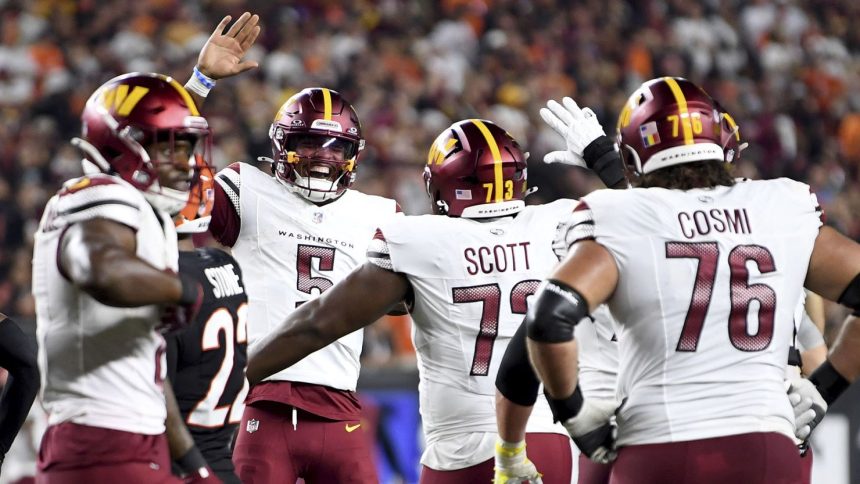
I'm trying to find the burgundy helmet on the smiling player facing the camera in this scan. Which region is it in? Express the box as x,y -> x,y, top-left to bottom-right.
269,87 -> 364,203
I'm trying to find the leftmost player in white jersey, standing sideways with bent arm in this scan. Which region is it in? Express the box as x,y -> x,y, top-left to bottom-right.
33,73 -> 210,483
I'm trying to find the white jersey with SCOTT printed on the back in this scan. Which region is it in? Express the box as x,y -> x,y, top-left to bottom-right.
370,200 -> 575,470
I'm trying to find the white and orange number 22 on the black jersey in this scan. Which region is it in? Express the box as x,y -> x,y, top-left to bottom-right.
187,304 -> 248,427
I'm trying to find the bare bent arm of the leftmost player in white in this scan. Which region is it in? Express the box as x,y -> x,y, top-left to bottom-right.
59,218 -> 191,307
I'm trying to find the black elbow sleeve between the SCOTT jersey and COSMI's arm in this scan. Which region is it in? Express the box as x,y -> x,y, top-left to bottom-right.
496,323 -> 540,407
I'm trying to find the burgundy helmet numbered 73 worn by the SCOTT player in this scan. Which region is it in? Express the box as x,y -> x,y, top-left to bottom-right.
424,119 -> 527,218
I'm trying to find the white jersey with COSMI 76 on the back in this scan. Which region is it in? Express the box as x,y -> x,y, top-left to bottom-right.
557,179 -> 822,445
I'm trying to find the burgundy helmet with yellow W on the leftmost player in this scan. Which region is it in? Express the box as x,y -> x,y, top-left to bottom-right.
72,72 -> 212,216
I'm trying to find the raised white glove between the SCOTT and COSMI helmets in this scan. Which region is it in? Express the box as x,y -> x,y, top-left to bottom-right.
540,97 -> 606,168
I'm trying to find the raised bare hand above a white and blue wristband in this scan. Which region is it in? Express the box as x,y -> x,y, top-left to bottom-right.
197,12 -> 260,79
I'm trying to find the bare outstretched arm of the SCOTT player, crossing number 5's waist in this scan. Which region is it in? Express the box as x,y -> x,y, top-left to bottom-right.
247,262 -> 410,385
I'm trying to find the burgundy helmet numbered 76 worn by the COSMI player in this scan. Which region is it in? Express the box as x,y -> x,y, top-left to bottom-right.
617,77 -> 726,175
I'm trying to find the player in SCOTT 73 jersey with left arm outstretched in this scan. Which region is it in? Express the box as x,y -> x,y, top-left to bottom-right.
248,120 -> 573,483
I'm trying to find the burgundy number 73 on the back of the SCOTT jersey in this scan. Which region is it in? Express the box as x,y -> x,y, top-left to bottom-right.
451,279 -> 540,376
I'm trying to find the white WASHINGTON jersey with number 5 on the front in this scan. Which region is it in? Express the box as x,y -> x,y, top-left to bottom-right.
216,164 -> 397,391
